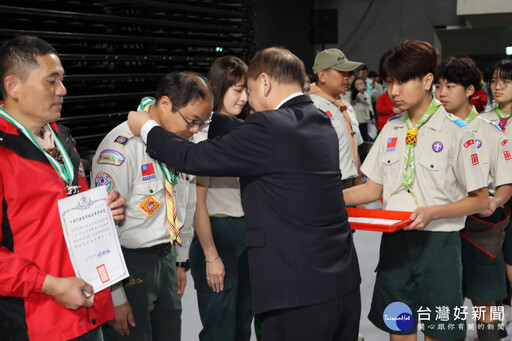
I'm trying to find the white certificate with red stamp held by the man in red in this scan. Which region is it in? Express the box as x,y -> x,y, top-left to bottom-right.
58,186 -> 128,293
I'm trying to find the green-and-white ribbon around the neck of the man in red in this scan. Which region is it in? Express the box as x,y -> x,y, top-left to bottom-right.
0,107 -> 80,195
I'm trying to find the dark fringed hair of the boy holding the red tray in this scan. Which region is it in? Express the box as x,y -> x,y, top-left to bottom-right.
379,40 -> 438,82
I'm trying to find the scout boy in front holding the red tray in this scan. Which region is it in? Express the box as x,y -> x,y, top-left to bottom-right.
343,40 -> 489,340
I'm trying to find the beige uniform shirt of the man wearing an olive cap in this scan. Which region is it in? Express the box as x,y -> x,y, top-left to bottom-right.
310,95 -> 359,180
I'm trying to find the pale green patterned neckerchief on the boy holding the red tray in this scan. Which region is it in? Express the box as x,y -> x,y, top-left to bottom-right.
391,97 -> 441,205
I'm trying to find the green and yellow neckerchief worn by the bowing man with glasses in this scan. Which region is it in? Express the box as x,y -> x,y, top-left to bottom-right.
137,97 -> 181,245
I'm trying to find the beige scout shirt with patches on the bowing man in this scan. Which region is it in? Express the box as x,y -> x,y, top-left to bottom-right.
91,122 -> 196,255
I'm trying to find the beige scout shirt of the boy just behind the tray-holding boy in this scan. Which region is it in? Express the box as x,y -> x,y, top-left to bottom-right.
468,115 -> 512,194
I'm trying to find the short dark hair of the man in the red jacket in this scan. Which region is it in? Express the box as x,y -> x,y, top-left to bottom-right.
0,36 -> 57,100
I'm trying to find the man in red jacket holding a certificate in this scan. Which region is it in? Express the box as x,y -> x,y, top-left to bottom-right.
0,36 -> 126,341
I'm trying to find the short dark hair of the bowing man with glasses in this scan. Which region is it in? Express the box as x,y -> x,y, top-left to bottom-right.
155,71 -> 213,112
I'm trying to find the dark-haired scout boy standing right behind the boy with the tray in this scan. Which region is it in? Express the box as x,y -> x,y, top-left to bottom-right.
435,58 -> 512,341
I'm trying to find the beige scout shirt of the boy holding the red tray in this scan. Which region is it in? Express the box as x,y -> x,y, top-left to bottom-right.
361,106 -> 487,231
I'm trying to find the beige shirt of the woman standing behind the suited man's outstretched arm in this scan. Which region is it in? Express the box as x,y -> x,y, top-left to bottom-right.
193,132 -> 244,217
